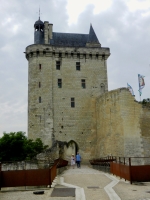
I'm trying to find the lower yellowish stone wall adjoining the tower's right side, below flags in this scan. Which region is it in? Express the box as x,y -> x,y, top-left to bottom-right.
96,88 -> 150,157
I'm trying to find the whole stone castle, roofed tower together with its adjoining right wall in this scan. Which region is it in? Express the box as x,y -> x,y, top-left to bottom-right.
25,18 -> 150,162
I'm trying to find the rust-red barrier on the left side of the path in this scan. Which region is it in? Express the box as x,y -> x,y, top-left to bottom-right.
0,163 -> 57,189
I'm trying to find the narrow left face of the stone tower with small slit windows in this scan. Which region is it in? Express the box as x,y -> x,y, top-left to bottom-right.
28,45 -> 53,146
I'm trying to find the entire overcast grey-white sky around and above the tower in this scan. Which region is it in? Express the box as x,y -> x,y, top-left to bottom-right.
0,0 -> 150,137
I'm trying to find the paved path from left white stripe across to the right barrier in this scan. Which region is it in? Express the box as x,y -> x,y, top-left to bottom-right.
58,166 -> 150,200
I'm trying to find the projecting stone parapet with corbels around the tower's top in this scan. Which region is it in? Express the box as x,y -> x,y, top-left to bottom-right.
25,45 -> 110,60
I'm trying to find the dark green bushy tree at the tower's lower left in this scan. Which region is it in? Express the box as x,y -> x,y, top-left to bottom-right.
0,132 -> 48,161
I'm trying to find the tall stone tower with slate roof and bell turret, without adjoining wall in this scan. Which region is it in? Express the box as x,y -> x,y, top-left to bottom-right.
26,18 -> 110,160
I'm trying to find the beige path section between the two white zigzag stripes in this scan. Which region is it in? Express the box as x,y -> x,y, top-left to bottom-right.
59,166 -> 119,200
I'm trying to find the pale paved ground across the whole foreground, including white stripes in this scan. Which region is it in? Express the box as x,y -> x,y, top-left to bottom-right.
0,166 -> 150,200
